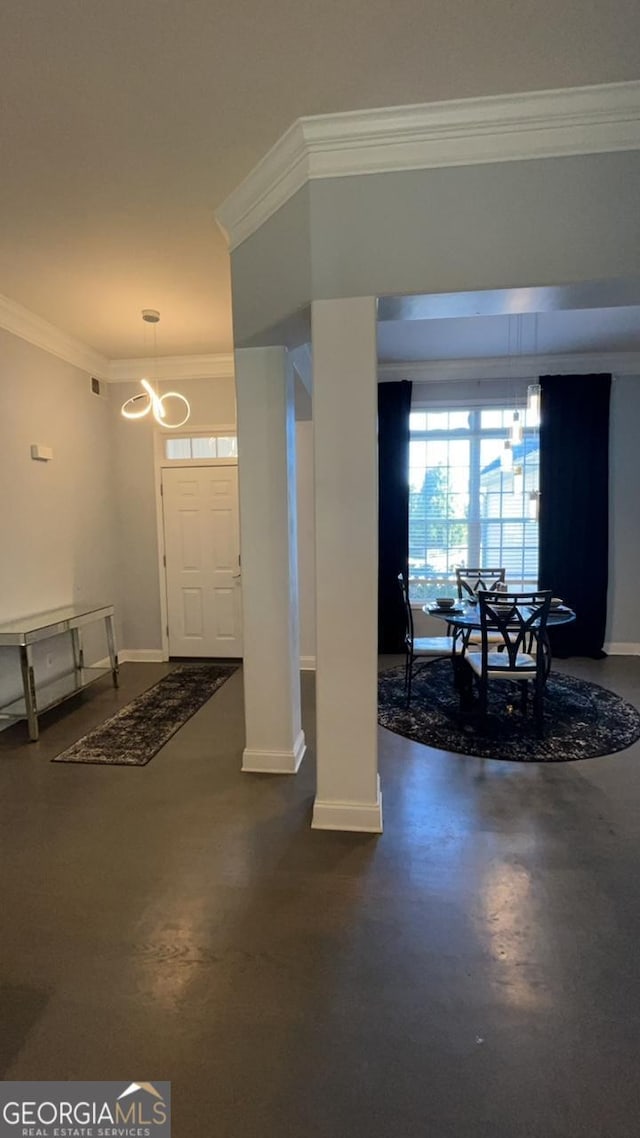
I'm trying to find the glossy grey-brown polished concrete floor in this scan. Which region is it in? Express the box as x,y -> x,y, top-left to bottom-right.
0,658 -> 640,1138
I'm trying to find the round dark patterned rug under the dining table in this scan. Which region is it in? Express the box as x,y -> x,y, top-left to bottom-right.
378,660 -> 640,762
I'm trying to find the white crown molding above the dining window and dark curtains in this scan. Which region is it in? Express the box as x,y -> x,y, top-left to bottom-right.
378,352 -> 640,382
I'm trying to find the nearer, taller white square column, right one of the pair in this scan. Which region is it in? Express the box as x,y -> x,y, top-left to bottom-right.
311,297 -> 383,833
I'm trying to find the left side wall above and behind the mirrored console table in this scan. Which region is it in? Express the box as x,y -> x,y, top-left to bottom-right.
0,331 -> 120,700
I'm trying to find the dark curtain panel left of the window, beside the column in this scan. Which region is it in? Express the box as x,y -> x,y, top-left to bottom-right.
378,380 -> 411,652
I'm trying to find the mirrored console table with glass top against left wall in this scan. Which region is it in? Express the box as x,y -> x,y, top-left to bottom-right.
0,604 -> 118,741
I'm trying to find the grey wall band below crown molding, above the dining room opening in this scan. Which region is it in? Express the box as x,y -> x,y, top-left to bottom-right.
305,150 -> 640,307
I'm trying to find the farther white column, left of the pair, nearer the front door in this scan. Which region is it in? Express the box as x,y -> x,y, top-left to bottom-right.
236,348 -> 305,774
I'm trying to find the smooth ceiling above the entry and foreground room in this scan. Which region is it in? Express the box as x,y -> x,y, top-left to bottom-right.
0,0 -> 640,358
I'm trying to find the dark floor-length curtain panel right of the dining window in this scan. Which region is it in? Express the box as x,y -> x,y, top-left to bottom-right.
540,376 -> 612,659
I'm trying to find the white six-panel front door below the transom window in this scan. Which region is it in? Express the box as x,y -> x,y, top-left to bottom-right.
162,465 -> 243,657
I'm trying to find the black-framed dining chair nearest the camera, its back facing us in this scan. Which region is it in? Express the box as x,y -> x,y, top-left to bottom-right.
465,589 -> 551,735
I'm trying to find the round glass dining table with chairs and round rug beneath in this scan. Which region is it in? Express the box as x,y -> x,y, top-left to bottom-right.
379,566 -> 640,761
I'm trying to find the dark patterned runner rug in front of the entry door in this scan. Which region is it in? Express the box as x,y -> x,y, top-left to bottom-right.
51,663 -> 237,767
